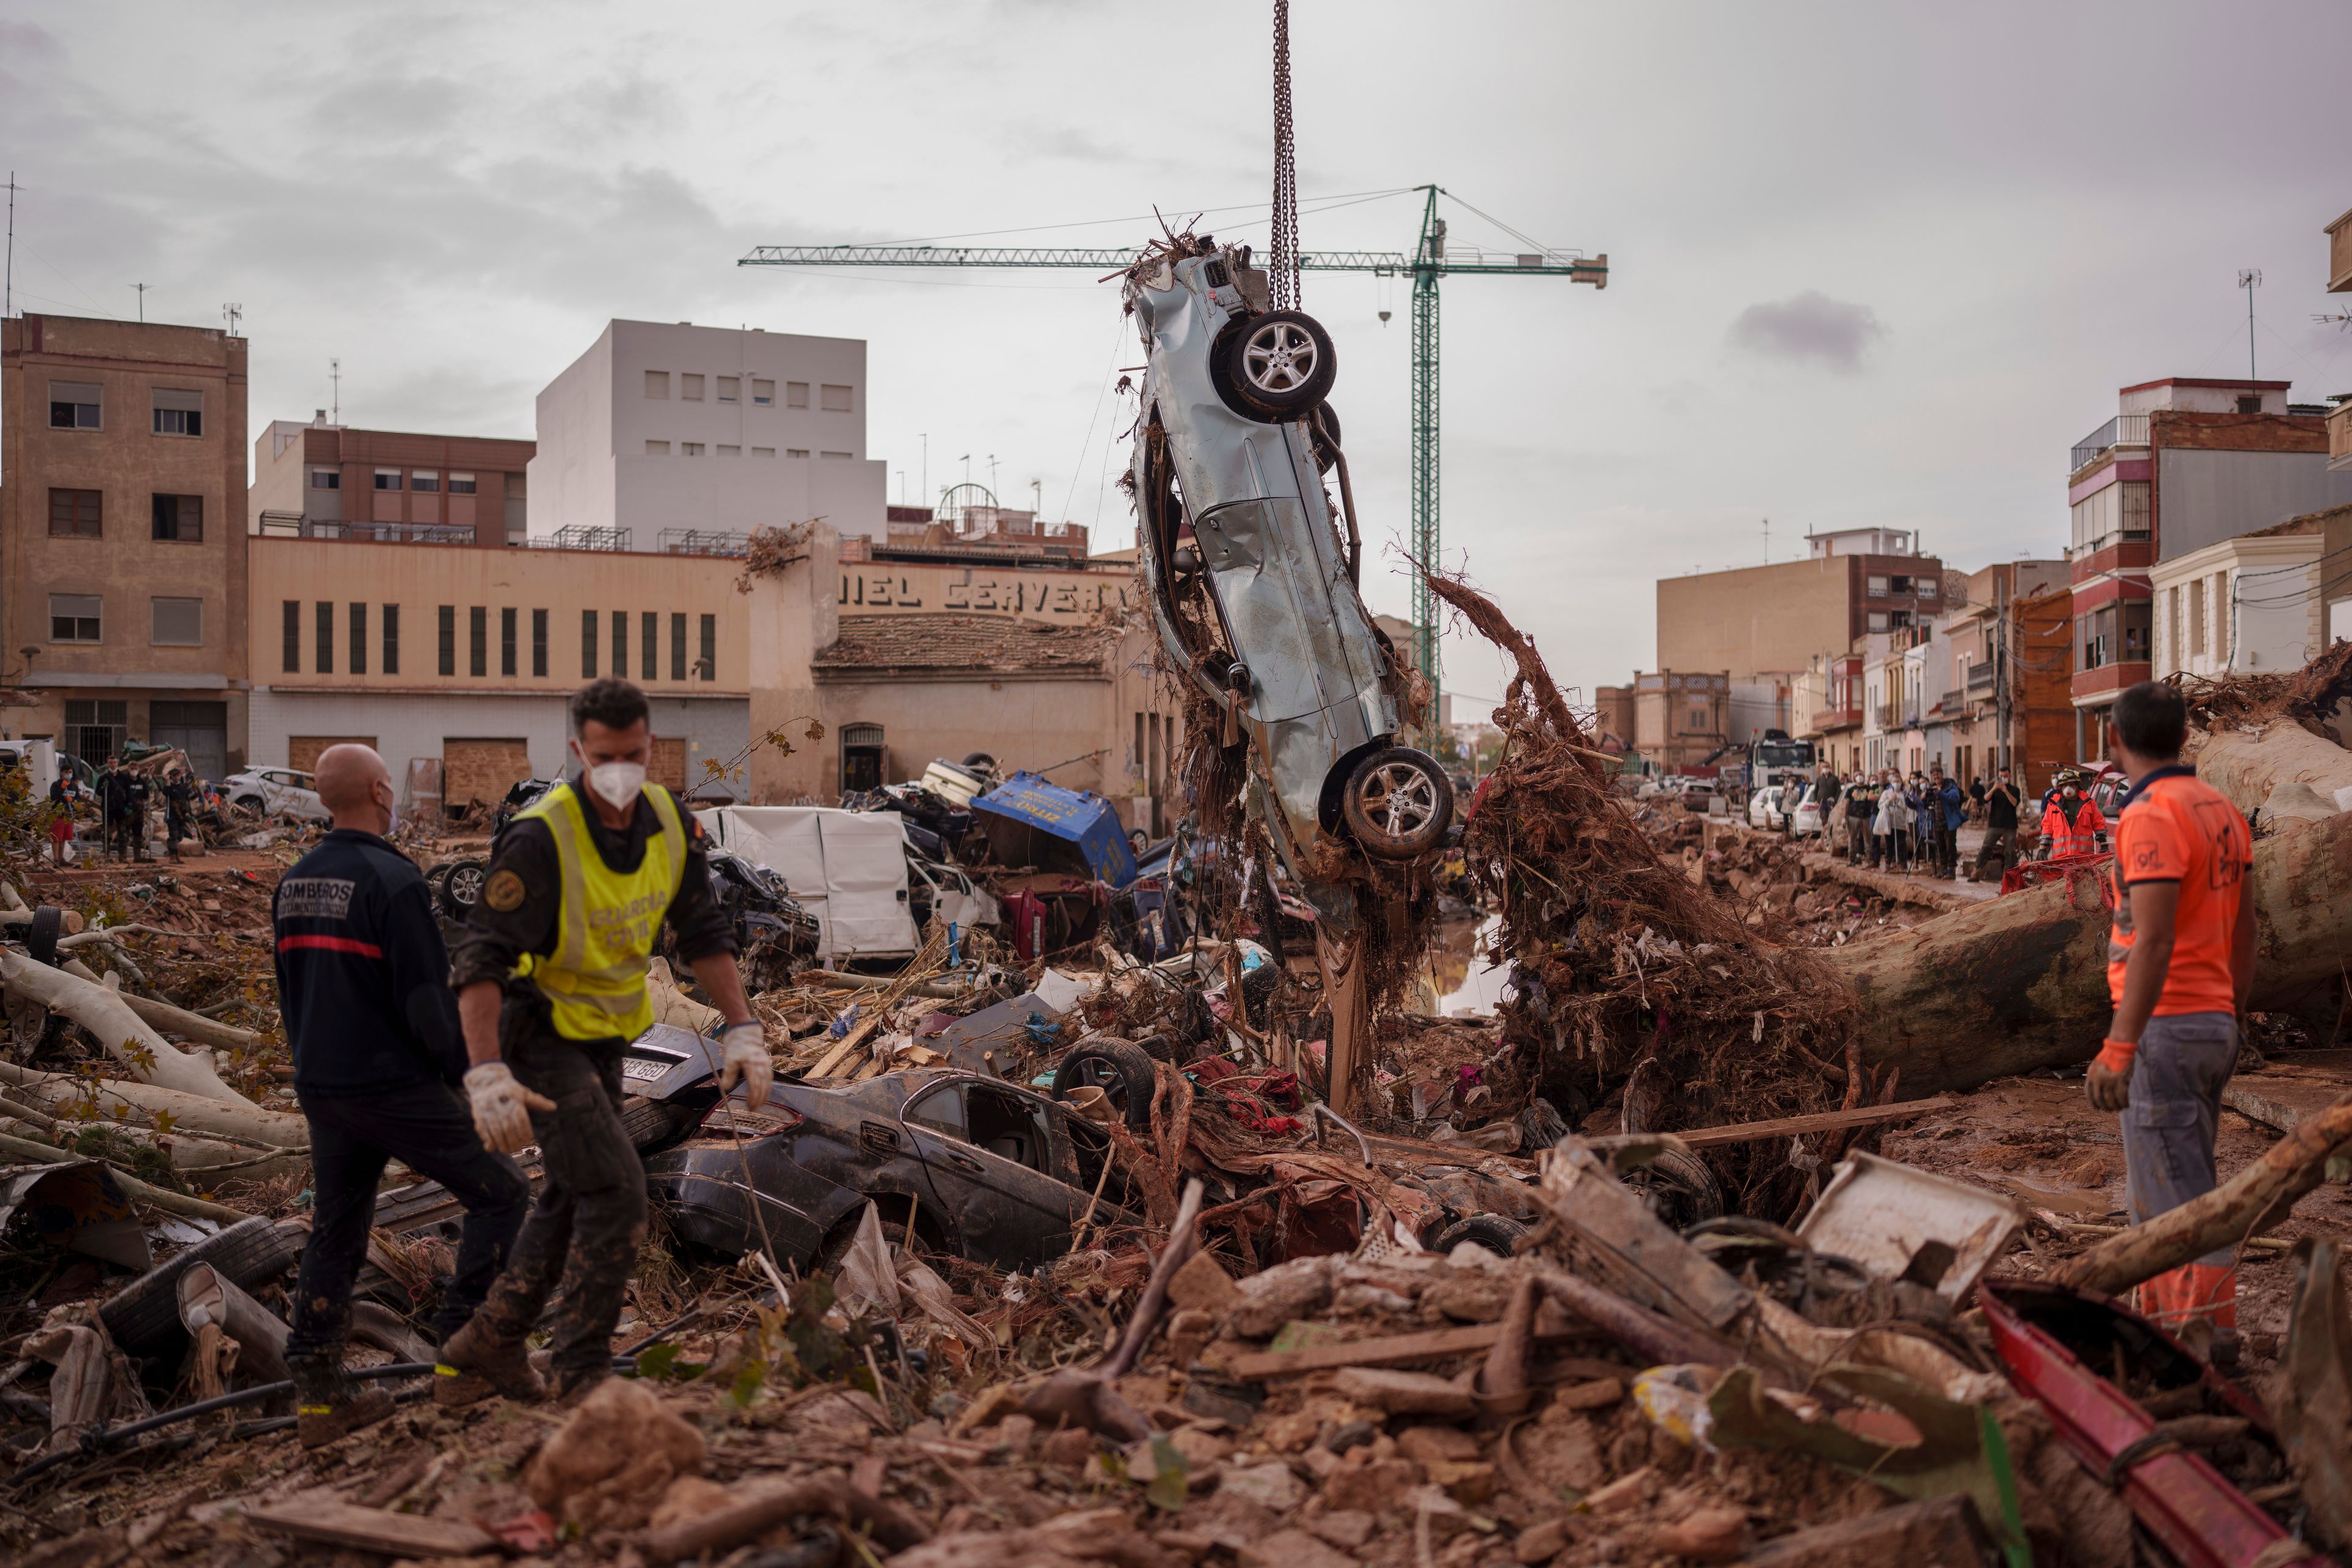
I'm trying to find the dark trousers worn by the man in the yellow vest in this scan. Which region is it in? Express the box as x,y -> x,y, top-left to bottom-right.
463,1025 -> 647,1394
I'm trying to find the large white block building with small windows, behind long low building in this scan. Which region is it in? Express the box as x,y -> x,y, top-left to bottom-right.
529,320 -> 887,550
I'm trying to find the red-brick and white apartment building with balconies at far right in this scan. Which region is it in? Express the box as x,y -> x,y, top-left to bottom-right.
2067,376 -> 2352,762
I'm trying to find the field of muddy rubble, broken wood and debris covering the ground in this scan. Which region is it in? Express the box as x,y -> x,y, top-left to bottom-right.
0,620 -> 2352,1568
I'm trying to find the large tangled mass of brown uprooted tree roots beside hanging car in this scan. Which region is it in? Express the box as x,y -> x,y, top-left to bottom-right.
1425,573 -> 1865,1218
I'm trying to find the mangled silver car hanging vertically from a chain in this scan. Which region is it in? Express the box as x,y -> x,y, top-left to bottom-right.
1125,238 -> 1453,903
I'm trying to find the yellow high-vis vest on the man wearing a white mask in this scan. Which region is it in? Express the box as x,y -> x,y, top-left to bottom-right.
515,783 -> 687,1039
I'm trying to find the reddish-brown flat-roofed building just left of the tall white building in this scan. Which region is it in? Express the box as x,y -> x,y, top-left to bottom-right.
244,409 -> 534,548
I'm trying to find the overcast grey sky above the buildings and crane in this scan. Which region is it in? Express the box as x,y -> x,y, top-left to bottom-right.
0,0 -> 2352,698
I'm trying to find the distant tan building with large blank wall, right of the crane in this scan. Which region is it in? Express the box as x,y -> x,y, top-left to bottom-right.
1658,529 -> 1943,679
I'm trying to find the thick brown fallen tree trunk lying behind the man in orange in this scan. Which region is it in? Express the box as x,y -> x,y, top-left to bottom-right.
1820,816 -> 2352,1096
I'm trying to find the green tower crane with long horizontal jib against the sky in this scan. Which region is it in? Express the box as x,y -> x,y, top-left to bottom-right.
736,186 -> 1609,696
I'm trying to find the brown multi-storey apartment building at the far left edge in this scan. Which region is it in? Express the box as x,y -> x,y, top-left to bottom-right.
0,312 -> 247,774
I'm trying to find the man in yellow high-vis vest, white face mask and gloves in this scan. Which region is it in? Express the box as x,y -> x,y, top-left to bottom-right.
435,679 -> 774,1406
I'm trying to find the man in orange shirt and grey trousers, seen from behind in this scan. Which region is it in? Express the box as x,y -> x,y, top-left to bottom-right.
2084,682 -> 2253,1344
